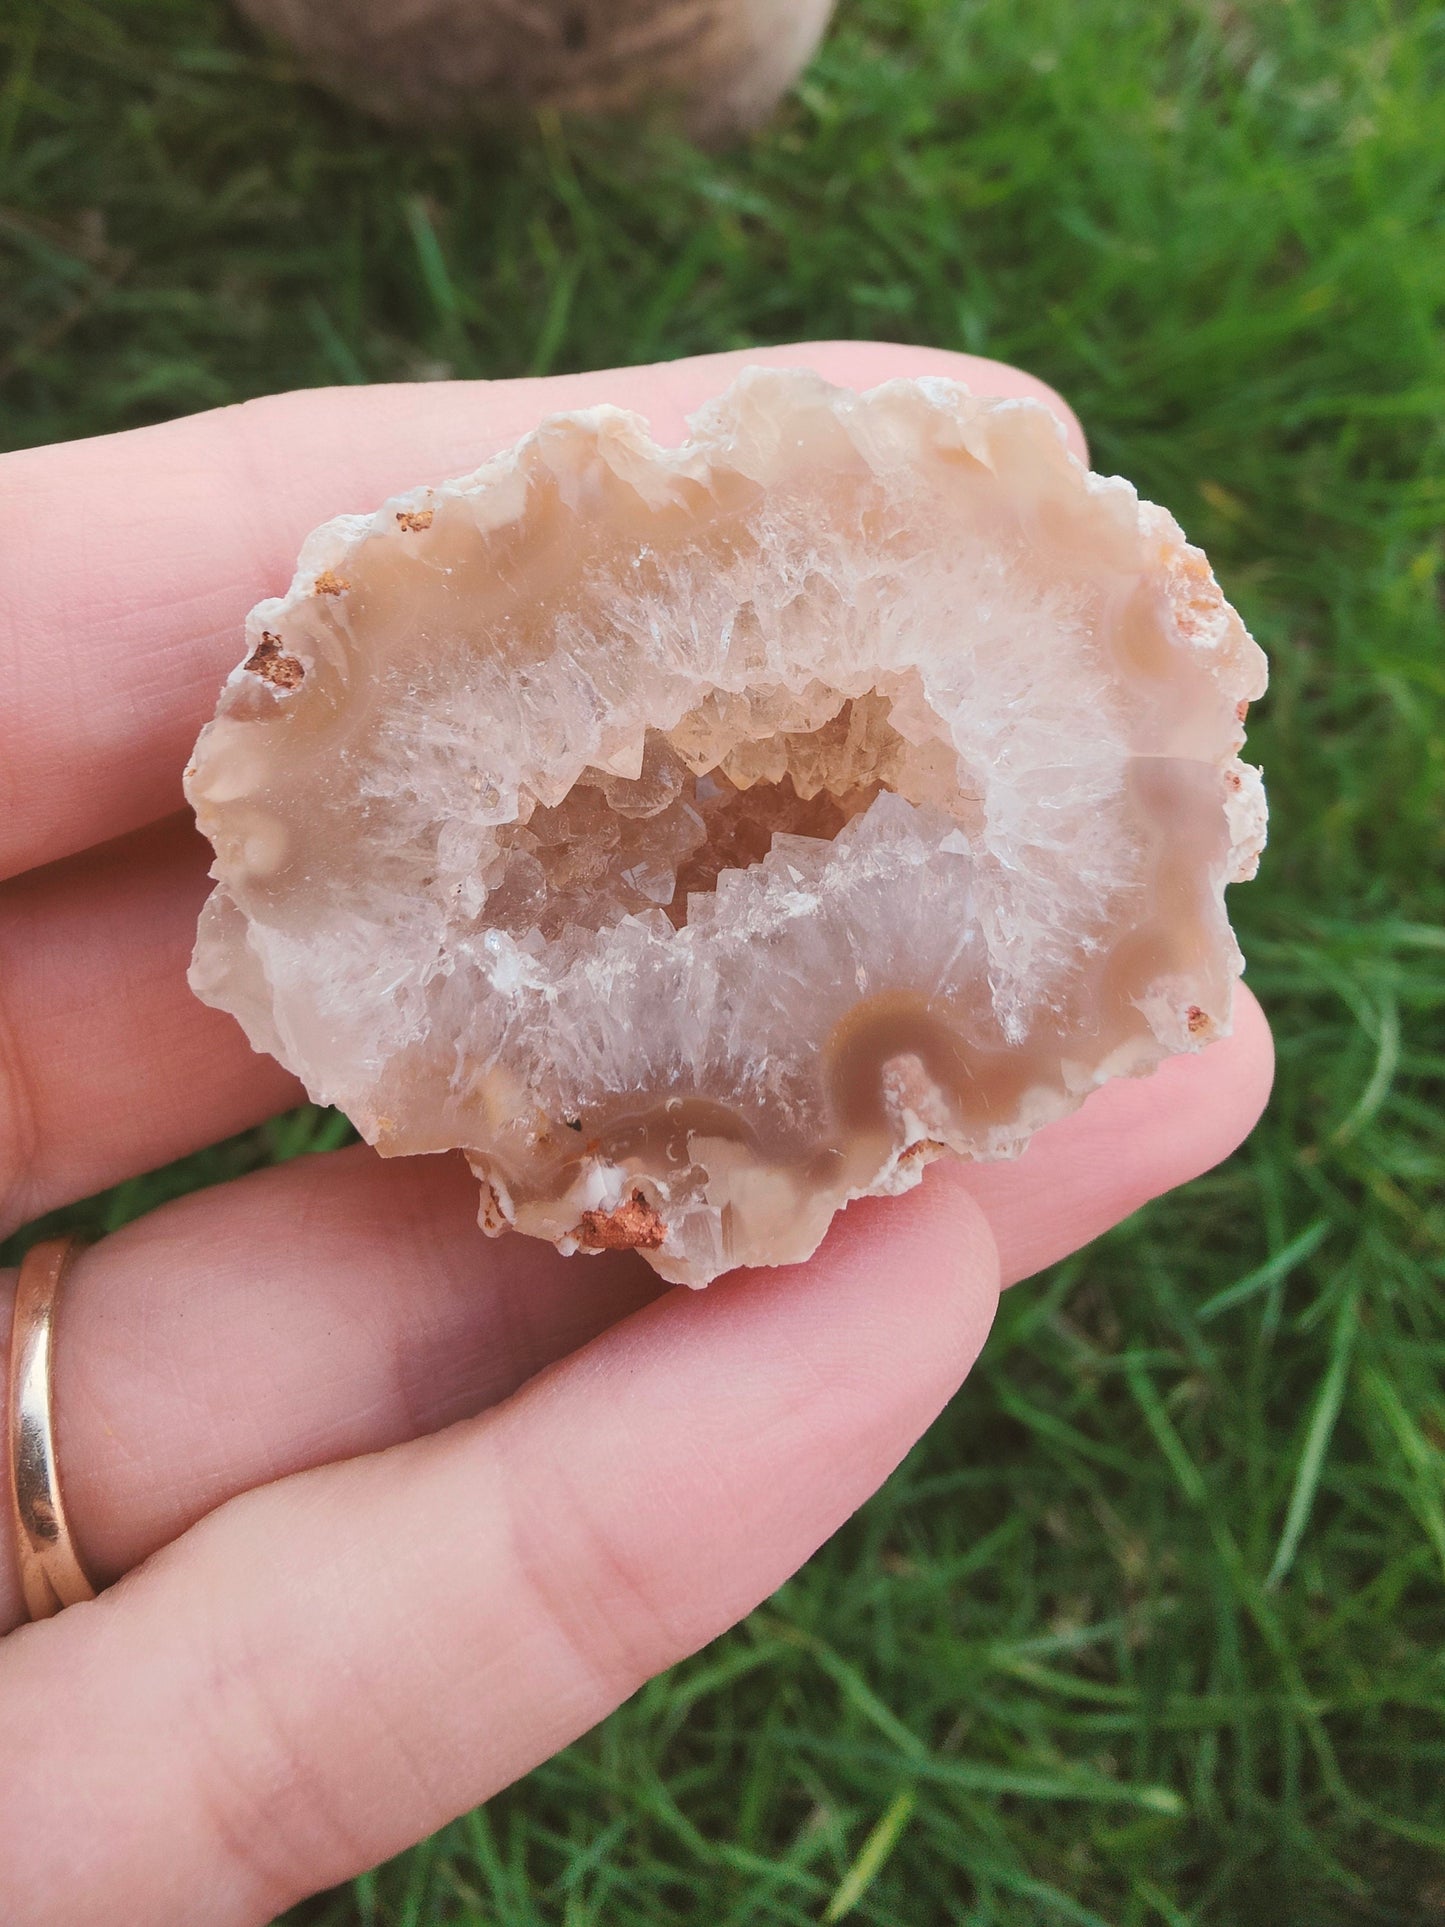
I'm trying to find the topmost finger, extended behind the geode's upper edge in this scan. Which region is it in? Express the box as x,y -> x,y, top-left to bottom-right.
0,341 -> 1085,877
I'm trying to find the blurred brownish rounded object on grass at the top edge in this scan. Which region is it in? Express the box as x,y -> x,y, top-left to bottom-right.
237,0 -> 834,141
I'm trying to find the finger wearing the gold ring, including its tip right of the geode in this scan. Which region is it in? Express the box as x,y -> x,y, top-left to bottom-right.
0,990 -> 1270,1630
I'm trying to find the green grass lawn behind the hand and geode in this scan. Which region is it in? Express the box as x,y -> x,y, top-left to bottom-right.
0,0 -> 1445,1927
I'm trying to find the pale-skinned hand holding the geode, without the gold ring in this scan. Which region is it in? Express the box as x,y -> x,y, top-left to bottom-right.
0,343 -> 1272,1927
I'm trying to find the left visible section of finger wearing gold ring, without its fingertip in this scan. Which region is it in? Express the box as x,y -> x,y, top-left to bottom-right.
0,1145 -> 661,1632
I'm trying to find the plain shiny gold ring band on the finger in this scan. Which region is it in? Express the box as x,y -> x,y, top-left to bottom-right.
10,1237 -> 94,1619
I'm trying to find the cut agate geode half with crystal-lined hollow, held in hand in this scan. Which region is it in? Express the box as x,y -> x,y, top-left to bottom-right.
187,370 -> 1264,1283
